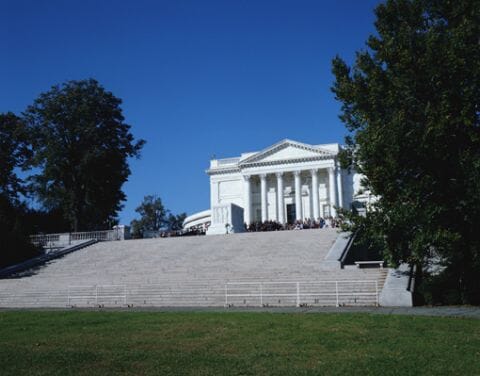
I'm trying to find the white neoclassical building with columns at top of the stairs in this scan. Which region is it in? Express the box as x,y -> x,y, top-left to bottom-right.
185,140 -> 368,231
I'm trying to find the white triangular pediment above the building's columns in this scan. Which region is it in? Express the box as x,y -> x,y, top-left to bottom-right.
241,140 -> 333,165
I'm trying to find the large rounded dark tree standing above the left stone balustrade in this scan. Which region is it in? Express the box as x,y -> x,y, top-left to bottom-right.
24,79 -> 145,231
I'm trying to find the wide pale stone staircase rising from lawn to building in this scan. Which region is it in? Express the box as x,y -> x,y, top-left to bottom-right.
0,229 -> 386,307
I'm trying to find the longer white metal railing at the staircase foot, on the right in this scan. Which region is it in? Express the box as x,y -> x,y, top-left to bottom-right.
225,280 -> 379,307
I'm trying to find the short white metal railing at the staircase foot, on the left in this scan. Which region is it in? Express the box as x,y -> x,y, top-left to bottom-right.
67,285 -> 127,306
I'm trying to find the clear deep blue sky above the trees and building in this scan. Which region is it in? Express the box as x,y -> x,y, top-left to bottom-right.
0,0 -> 380,223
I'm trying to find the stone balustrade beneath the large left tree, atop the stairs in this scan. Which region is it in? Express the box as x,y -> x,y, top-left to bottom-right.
30,229 -> 122,248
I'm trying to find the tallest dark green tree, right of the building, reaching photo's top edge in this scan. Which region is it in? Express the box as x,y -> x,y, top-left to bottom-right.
332,0 -> 480,304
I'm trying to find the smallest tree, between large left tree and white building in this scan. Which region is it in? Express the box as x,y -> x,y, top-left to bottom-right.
130,195 -> 167,238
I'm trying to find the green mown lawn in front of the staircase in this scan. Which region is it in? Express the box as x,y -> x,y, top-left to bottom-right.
0,311 -> 480,375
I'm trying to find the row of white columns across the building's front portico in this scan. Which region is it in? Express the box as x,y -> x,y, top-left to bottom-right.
243,167 -> 343,223
